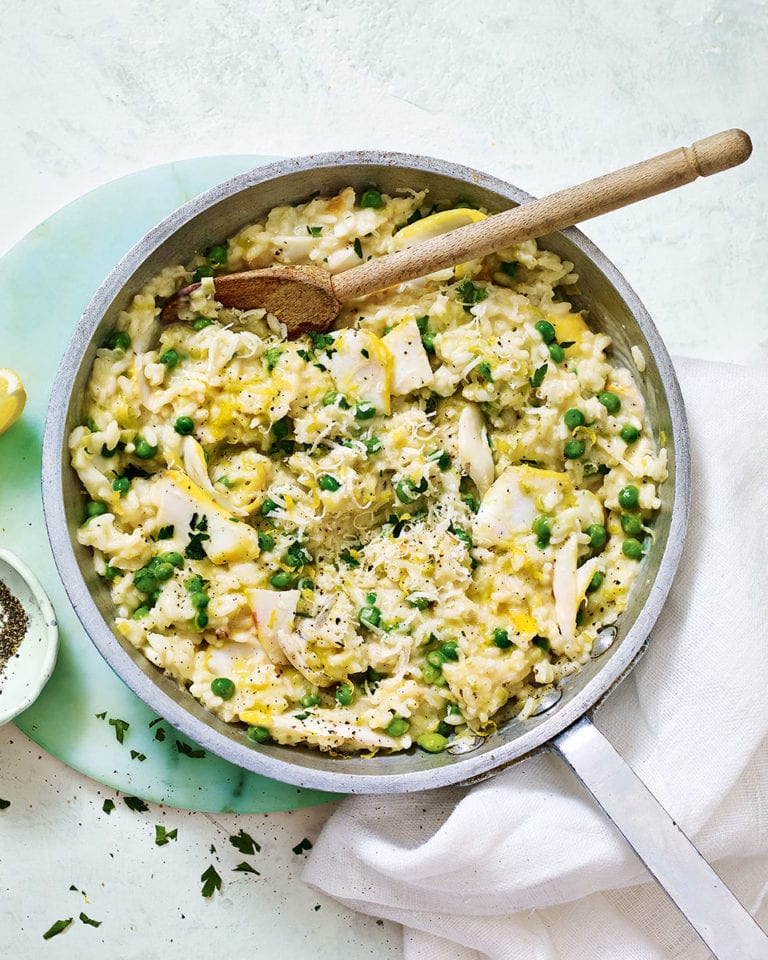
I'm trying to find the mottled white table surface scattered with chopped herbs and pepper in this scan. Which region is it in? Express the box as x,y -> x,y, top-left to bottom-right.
0,0 -> 768,960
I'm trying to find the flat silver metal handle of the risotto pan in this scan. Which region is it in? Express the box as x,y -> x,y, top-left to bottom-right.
553,717 -> 768,960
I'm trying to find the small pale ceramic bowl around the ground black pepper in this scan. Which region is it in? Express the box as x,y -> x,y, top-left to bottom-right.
0,549 -> 59,724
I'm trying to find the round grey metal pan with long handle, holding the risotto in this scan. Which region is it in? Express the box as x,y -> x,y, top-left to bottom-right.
43,152 -> 768,960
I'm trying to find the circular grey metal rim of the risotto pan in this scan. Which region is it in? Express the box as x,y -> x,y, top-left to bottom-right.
42,150 -> 691,794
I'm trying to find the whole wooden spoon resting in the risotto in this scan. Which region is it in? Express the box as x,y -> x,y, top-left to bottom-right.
160,129 -> 752,337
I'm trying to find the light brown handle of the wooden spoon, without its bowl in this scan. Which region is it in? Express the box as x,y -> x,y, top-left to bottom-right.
332,130 -> 752,302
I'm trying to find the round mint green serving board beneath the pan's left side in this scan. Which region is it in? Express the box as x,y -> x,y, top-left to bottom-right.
0,156 -> 335,813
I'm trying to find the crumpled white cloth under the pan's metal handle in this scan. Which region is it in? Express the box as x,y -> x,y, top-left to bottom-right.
304,360 -> 768,960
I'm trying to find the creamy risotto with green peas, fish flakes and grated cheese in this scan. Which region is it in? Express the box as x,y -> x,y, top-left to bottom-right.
69,188 -> 666,753
